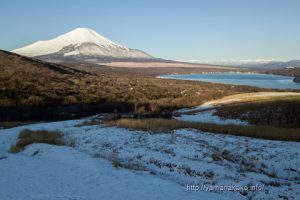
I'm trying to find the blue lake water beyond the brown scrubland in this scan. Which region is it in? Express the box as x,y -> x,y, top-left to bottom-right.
160,73 -> 300,89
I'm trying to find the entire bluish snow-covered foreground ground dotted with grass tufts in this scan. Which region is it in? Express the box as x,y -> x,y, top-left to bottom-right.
0,118 -> 300,200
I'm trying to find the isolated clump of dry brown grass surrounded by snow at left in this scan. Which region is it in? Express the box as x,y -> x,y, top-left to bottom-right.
10,129 -> 63,153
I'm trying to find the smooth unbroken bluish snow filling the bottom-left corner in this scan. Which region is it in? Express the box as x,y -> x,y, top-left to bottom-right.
0,144 -> 224,200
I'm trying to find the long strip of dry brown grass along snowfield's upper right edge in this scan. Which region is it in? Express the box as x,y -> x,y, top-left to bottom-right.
107,118 -> 300,142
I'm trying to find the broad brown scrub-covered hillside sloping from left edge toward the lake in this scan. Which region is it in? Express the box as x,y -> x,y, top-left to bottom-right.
0,51 -> 264,121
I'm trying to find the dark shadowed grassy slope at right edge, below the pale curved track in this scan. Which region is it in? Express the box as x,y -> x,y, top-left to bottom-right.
216,96 -> 300,128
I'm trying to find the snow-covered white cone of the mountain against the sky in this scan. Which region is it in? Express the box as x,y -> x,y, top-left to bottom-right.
12,28 -> 156,62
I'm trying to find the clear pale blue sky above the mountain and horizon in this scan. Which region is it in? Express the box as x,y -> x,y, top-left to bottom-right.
0,0 -> 300,62
